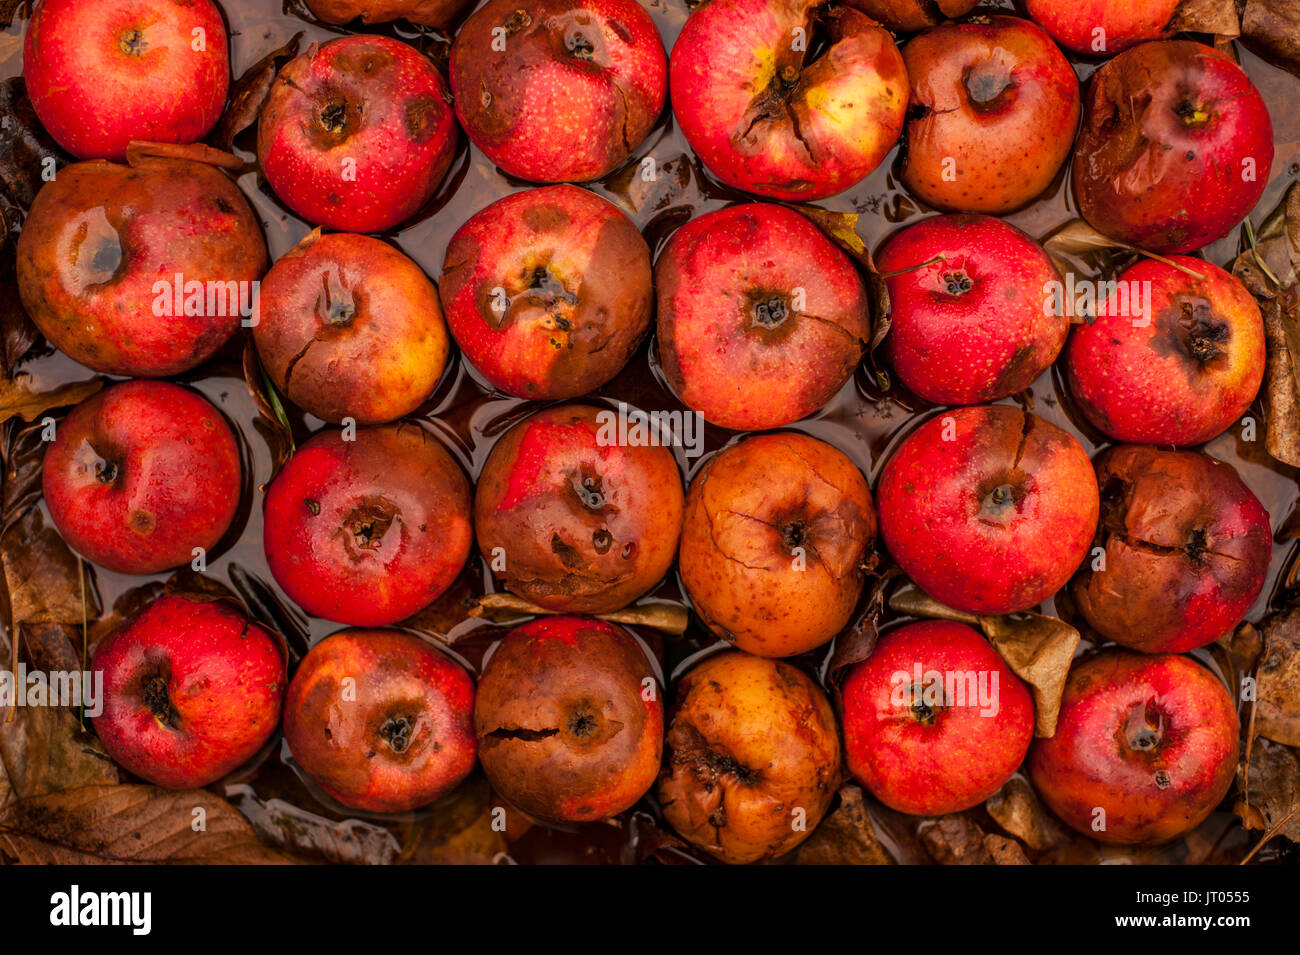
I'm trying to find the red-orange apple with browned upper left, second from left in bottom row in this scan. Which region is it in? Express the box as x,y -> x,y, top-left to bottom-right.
285,630 -> 476,812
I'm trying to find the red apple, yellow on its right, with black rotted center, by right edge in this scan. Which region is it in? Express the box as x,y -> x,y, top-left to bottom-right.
1065,256 -> 1265,446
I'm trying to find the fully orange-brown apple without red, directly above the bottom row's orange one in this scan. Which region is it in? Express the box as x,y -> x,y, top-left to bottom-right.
679,433 -> 876,656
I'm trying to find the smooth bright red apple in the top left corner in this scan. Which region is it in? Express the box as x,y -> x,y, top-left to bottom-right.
22,0 -> 230,160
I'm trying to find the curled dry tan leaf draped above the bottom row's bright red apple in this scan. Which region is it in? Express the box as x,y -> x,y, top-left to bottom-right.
889,583 -> 1079,737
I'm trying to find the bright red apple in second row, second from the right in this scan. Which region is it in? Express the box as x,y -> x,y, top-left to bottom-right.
876,216 -> 1070,404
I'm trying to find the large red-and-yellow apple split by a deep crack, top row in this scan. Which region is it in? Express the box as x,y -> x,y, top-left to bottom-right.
670,0 -> 907,201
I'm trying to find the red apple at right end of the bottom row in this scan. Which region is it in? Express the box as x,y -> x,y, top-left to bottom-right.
1027,650 -> 1239,845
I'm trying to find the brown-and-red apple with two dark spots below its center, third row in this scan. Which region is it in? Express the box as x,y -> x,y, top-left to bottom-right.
475,404 -> 683,613
